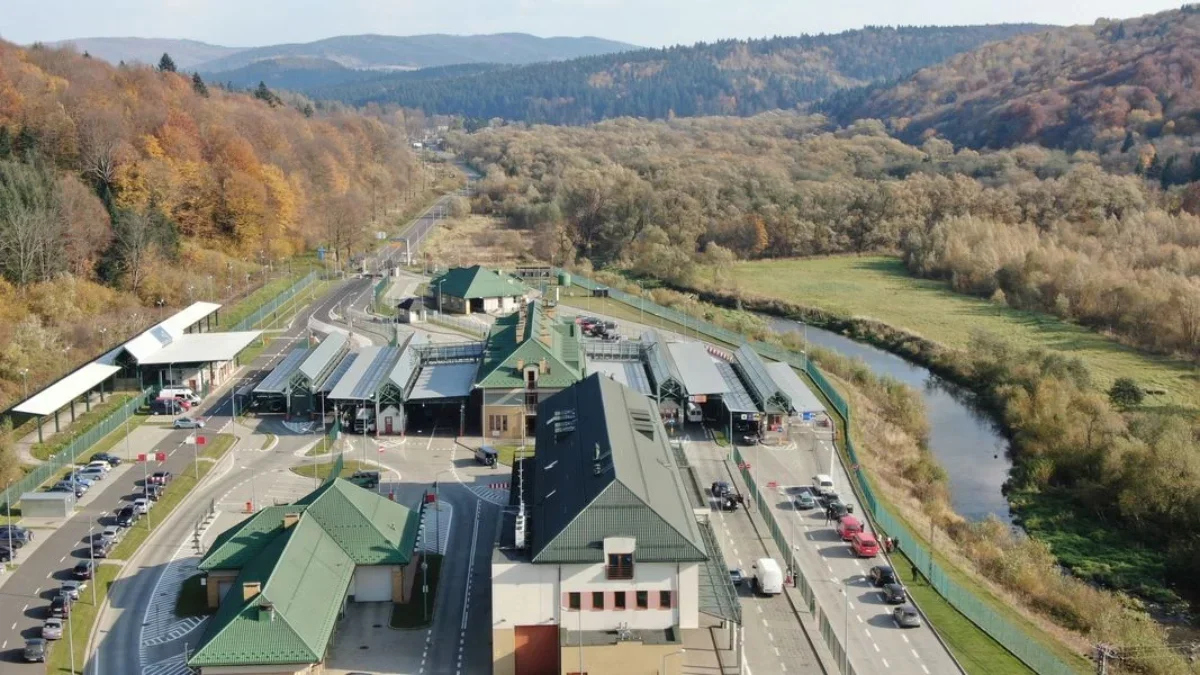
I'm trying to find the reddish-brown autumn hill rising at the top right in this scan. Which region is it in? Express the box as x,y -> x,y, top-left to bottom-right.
823,5 -> 1200,158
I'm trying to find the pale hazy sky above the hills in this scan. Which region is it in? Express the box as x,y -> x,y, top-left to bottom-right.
0,0 -> 1182,47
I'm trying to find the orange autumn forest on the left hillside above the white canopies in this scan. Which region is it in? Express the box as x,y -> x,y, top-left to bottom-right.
0,42 -> 421,441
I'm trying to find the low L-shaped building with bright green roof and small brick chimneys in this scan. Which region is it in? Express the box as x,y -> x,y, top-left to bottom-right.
187,478 -> 419,674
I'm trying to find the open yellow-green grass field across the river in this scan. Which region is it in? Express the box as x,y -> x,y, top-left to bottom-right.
734,256 -> 1200,408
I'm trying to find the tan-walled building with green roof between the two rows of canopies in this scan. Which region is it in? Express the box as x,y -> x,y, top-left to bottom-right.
475,300 -> 586,438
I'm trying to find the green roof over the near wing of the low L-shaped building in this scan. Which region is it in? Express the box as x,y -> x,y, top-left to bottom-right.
187,516 -> 354,668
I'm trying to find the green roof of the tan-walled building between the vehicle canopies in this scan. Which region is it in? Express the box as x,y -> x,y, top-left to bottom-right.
476,301 -> 583,389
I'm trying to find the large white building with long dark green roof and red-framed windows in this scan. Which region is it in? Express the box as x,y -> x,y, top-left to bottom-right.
492,374 -> 740,675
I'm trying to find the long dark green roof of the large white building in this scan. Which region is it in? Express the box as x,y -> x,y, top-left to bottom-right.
532,375 -> 708,563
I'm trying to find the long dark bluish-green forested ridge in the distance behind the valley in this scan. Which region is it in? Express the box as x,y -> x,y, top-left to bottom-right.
311,24 -> 1043,124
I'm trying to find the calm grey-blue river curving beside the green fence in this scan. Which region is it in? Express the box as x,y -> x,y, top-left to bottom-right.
763,316 -> 1013,522
